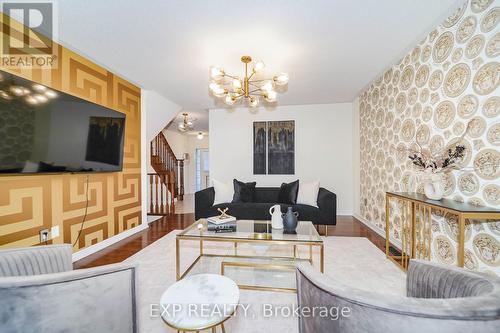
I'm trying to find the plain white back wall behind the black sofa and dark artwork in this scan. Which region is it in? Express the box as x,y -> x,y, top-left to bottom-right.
209,103 -> 354,215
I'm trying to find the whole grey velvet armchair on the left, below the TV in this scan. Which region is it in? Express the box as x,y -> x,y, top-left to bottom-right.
0,244 -> 137,333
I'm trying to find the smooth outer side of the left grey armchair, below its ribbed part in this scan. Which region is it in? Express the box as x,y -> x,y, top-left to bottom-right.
0,264 -> 138,333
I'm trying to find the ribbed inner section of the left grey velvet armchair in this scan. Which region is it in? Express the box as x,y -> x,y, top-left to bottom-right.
0,244 -> 73,277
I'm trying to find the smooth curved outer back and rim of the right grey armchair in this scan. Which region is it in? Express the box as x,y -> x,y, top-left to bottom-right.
296,262 -> 500,333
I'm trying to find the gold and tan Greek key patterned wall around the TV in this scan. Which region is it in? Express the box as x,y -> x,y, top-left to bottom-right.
0,14 -> 141,251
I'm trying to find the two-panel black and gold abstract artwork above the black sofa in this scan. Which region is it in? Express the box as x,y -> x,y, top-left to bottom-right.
253,120 -> 295,175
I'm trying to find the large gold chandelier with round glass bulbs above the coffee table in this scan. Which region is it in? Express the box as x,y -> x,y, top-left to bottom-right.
208,56 -> 288,107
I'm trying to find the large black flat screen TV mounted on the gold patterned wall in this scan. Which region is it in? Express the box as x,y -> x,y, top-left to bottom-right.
0,71 -> 125,174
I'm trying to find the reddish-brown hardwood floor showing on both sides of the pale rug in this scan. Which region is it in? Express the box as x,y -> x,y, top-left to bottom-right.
73,213 -> 385,269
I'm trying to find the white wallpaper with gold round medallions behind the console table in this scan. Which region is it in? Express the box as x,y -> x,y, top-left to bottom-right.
359,0 -> 500,275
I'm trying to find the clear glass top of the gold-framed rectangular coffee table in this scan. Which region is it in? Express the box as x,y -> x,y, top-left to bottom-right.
177,219 -> 322,242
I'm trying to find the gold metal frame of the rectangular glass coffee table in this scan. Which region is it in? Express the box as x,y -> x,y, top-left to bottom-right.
175,221 -> 325,293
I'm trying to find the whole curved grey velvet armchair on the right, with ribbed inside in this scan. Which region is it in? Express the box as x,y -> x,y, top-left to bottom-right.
297,260 -> 500,333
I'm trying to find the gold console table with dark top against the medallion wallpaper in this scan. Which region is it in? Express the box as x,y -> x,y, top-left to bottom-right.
385,192 -> 500,270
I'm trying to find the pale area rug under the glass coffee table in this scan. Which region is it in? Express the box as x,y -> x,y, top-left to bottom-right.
125,230 -> 406,333
